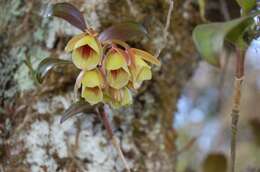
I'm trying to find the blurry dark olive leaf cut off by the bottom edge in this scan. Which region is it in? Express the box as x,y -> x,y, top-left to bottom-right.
202,153 -> 227,172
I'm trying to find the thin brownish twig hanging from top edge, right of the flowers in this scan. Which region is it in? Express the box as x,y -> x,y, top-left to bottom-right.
155,0 -> 174,57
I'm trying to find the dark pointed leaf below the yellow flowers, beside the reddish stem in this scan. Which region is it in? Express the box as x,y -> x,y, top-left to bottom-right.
60,100 -> 95,123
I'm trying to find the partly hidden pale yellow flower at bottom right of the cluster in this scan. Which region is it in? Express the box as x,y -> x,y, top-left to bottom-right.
104,87 -> 133,109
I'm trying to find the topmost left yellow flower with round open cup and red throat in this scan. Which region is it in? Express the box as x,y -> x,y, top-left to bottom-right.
65,33 -> 102,70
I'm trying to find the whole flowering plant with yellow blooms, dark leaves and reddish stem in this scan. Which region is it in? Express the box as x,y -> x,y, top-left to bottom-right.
28,3 -> 160,171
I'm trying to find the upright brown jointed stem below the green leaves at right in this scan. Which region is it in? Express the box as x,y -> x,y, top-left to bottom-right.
230,49 -> 245,172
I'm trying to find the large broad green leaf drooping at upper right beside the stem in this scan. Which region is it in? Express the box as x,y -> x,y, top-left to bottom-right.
192,12 -> 260,67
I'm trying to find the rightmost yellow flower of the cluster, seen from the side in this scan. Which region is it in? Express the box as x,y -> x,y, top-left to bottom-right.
128,48 -> 160,89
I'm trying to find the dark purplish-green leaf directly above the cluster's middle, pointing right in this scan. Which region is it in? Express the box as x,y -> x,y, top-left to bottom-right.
98,22 -> 147,42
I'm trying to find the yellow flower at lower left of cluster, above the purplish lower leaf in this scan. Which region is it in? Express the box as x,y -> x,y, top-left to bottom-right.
81,69 -> 104,105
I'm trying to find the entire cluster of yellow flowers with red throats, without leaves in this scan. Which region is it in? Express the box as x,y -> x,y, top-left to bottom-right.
65,33 -> 160,108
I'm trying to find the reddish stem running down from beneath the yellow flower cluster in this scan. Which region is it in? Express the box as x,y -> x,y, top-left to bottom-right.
98,106 -> 131,172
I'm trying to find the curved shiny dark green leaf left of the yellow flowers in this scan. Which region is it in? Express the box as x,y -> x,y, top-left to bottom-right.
36,57 -> 72,83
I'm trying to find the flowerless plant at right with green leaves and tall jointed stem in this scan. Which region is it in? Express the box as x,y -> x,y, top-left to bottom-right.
193,0 -> 260,172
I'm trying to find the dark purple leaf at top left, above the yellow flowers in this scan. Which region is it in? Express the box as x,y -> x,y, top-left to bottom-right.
50,2 -> 87,32
